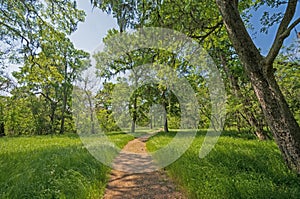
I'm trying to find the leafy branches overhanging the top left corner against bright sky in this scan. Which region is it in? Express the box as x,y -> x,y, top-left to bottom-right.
0,0 -> 85,66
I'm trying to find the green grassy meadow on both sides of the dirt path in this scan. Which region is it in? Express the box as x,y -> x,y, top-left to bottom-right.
0,131 -> 300,199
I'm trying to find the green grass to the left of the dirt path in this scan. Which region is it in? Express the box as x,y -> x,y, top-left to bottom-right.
0,132 -> 133,198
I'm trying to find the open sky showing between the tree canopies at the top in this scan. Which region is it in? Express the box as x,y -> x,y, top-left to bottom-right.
70,0 -> 300,55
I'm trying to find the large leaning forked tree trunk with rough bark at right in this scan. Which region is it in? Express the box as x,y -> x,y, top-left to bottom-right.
216,0 -> 300,174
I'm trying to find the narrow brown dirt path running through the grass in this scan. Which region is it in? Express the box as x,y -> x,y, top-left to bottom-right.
103,131 -> 186,199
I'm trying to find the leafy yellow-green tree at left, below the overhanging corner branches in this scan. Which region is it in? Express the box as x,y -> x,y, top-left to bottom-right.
14,33 -> 88,134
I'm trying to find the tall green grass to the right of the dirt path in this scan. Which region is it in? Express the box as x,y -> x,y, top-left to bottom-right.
147,132 -> 300,199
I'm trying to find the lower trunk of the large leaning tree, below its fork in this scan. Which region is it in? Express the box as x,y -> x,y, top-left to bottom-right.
252,67 -> 300,173
